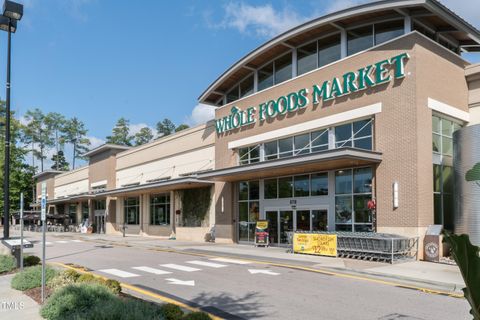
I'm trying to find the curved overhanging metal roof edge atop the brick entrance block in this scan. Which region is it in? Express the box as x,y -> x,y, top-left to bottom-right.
198,0 -> 480,103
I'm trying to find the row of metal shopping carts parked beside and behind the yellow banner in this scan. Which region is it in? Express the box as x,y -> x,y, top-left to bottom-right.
289,231 -> 418,263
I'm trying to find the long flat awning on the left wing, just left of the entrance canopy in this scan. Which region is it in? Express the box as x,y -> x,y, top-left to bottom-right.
96,177 -> 213,197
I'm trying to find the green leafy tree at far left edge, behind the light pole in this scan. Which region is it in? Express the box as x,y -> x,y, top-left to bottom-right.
0,100 -> 35,218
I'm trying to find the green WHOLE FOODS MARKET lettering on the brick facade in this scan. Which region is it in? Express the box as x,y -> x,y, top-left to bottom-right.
215,53 -> 409,133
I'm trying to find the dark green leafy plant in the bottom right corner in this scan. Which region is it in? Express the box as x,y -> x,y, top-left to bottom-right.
443,232 -> 480,320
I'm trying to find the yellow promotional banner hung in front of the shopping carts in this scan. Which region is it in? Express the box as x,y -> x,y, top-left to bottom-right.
293,233 -> 337,257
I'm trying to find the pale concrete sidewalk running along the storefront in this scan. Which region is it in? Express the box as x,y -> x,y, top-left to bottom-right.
14,232 -> 465,294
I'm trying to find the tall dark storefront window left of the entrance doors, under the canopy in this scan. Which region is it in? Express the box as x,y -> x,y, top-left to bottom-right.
238,181 -> 260,242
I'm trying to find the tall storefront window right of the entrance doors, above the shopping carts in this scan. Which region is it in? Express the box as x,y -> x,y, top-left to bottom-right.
335,167 -> 372,232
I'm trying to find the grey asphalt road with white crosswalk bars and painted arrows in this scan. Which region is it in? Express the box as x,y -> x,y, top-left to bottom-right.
21,232 -> 471,320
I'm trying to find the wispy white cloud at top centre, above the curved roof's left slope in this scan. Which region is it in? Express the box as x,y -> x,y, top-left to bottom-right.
211,2 -> 307,37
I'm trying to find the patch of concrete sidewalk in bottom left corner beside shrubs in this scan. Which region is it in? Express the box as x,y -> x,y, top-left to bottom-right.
0,274 -> 42,320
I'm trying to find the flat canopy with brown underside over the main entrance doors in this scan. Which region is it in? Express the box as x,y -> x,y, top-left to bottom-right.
198,148 -> 382,182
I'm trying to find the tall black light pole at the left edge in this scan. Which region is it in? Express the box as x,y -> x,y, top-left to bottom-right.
0,0 -> 23,239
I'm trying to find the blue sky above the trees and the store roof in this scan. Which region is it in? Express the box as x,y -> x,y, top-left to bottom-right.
4,0 -> 480,151
